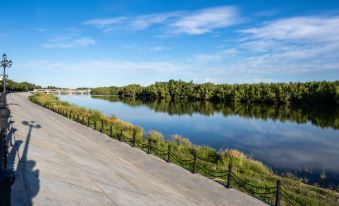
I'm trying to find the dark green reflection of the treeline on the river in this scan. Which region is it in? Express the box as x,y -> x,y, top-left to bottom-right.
92,96 -> 339,129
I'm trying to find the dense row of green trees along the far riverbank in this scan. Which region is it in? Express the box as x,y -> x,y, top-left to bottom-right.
91,80 -> 339,104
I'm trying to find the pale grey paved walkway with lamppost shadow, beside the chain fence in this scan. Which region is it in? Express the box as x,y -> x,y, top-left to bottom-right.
8,93 -> 265,206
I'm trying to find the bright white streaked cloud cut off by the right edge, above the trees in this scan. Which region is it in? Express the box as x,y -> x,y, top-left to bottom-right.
242,16 -> 339,42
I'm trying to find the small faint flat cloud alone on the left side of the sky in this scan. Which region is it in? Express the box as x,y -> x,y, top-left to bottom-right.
41,37 -> 96,48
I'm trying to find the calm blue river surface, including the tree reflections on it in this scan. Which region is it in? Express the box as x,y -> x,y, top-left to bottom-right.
60,95 -> 339,186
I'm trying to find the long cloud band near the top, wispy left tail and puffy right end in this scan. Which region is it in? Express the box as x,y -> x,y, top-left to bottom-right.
83,6 -> 241,35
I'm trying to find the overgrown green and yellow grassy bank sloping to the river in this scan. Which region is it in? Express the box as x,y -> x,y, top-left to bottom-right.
30,94 -> 339,205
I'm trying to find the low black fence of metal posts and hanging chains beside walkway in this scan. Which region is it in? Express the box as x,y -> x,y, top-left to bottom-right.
41,105 -> 314,206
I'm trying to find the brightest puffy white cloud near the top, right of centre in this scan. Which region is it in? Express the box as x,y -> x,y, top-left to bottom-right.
171,7 -> 240,35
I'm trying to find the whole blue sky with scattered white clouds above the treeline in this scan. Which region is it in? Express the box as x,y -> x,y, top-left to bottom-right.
0,0 -> 339,88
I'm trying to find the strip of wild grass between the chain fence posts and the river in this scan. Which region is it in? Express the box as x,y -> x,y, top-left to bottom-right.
31,95 -> 338,205
